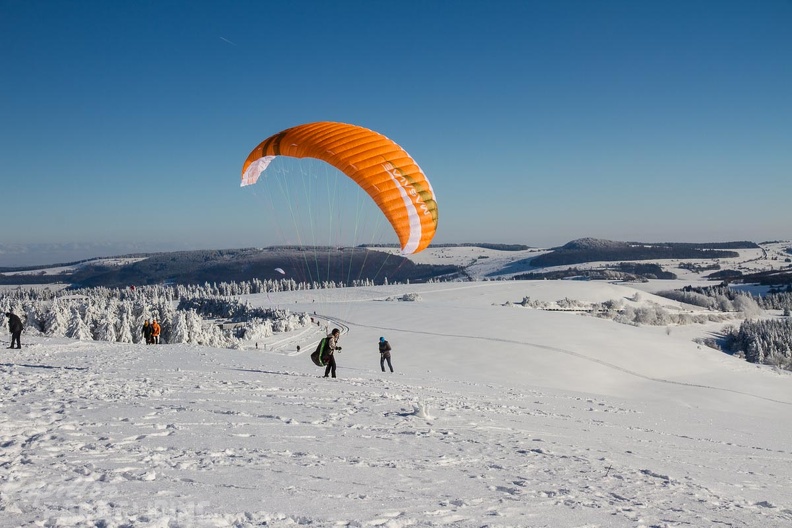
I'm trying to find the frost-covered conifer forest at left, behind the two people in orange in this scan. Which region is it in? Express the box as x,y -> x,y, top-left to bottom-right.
0,280 -> 318,347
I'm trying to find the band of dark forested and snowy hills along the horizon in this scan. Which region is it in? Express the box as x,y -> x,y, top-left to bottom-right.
0,238 -> 792,287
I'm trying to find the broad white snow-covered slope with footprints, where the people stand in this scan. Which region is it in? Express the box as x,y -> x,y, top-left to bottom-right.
0,281 -> 792,528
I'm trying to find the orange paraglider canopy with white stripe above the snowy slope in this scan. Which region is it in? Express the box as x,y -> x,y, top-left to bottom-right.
241,121 -> 437,256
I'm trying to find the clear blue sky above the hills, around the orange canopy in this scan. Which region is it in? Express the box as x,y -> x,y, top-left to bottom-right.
0,0 -> 792,266
